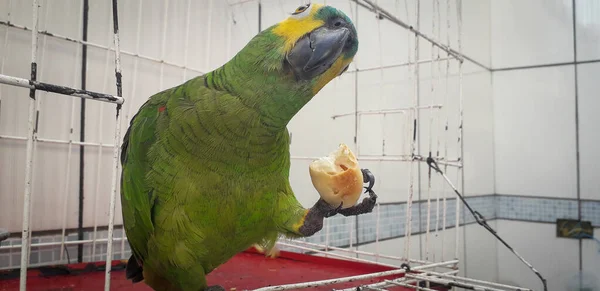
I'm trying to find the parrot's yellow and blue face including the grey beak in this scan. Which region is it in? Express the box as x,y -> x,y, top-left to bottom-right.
274,3 -> 358,94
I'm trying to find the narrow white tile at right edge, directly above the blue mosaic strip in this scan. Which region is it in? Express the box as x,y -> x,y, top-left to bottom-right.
577,63 -> 600,200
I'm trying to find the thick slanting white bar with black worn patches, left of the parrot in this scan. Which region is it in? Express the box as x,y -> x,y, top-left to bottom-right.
0,75 -> 125,104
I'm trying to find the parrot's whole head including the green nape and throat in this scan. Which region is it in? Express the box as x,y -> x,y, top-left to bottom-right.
214,3 -> 358,125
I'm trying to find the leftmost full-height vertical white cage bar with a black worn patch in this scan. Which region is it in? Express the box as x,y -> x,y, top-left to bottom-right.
19,0 -> 39,291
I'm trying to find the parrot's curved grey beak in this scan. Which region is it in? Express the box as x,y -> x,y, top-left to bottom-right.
286,26 -> 351,80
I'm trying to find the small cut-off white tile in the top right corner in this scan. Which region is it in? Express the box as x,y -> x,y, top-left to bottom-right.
575,0 -> 600,61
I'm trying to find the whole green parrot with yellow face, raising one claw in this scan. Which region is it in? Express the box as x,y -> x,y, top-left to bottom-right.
121,3 -> 377,291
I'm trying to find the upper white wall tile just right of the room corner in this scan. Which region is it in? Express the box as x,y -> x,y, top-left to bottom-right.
491,0 -> 573,68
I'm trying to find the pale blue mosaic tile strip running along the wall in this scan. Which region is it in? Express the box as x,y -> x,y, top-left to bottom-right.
0,195 -> 600,269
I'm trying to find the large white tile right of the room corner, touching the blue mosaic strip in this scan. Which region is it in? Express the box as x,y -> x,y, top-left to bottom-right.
492,66 -> 576,198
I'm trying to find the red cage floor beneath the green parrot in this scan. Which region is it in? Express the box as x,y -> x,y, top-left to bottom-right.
0,250 -> 436,291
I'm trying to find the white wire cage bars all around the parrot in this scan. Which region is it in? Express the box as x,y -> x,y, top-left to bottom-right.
0,0 -> 544,291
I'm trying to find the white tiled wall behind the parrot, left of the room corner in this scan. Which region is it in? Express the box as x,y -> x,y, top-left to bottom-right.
0,0 -> 496,288
